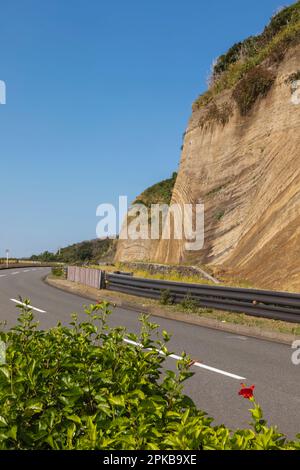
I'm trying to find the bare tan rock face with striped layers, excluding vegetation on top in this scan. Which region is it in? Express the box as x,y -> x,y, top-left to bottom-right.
117,45 -> 300,289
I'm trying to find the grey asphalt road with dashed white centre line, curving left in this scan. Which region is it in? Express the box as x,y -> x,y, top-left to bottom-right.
0,268 -> 300,438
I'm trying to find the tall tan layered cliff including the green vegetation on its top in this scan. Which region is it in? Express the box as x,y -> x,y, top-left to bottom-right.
117,1 -> 300,290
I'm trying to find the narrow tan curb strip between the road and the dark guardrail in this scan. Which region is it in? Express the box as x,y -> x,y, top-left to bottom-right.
44,276 -> 299,345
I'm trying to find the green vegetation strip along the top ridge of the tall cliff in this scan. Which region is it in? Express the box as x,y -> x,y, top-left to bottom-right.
193,1 -> 300,110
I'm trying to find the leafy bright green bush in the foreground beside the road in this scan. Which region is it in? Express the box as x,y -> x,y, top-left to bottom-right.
0,301 -> 300,450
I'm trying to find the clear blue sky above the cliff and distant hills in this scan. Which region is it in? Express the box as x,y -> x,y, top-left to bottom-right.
0,0 -> 293,256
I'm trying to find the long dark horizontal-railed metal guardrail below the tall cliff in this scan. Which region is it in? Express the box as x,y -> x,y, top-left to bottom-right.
105,273 -> 300,323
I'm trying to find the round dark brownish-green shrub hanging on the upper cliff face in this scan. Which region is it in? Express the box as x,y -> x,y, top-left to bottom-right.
233,66 -> 275,116
